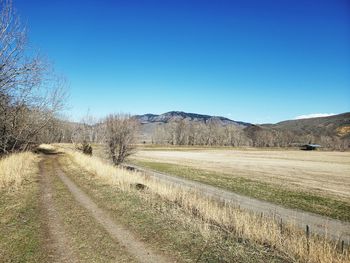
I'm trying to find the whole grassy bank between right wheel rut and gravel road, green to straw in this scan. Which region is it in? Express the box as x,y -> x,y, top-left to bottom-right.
61,152 -> 350,262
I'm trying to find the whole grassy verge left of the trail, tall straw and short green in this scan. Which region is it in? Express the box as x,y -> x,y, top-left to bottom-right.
0,152 -> 47,262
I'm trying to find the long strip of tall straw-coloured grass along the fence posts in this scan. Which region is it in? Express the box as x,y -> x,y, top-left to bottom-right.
67,151 -> 350,263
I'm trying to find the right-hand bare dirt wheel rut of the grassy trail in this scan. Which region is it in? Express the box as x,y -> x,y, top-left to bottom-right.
44,157 -> 172,263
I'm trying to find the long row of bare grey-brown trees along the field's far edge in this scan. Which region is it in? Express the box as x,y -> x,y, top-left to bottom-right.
152,119 -> 350,150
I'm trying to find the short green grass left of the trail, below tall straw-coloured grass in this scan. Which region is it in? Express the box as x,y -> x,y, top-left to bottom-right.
0,175 -> 48,262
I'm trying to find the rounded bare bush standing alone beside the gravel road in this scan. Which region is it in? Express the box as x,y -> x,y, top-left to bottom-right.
104,114 -> 139,165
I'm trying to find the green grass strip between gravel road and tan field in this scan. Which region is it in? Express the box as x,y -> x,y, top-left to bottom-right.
132,160 -> 350,222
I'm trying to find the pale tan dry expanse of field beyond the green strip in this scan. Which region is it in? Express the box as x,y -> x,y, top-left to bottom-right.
134,149 -> 350,201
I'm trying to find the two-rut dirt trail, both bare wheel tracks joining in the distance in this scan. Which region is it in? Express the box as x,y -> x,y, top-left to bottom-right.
40,155 -> 171,263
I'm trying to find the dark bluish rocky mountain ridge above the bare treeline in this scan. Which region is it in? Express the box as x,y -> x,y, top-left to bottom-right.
134,111 -> 251,127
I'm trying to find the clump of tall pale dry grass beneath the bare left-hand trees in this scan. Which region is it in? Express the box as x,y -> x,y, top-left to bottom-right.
0,152 -> 37,190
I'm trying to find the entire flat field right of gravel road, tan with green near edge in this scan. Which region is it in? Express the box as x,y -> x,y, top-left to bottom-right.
131,147 -> 350,221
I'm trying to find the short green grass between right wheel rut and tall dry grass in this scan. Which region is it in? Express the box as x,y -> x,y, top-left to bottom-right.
60,157 -> 286,262
